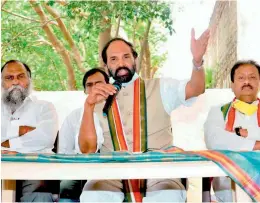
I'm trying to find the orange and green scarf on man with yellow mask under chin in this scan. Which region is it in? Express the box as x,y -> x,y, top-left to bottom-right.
221,98 -> 260,132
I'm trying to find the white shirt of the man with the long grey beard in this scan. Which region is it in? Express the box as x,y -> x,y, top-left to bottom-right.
1,96 -> 58,153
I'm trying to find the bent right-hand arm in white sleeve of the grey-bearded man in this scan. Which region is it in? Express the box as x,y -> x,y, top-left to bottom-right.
3,103 -> 58,152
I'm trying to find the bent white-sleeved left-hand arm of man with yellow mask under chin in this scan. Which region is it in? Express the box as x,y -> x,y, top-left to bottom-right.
204,107 -> 256,151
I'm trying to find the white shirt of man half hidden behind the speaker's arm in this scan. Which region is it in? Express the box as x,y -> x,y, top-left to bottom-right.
58,108 -> 104,154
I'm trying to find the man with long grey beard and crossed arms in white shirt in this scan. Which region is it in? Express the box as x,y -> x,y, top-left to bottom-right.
1,60 -> 58,202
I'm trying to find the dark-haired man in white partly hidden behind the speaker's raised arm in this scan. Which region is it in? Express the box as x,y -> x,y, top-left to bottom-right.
58,68 -> 109,202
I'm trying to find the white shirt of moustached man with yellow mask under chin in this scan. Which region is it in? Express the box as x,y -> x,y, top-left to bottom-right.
204,101 -> 260,151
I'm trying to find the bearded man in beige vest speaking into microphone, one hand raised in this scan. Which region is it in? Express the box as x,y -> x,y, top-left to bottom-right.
79,27 -> 209,202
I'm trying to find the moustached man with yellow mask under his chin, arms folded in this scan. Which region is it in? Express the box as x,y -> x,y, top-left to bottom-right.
204,60 -> 260,202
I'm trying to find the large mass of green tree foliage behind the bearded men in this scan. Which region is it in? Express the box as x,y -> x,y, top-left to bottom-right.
1,0 -> 174,91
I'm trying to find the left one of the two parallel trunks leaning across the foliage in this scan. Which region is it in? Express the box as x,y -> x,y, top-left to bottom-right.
30,0 -> 76,90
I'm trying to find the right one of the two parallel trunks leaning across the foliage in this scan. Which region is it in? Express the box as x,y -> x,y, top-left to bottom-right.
43,3 -> 86,73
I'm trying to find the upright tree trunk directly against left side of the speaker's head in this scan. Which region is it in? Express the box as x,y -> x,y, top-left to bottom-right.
98,18 -> 111,67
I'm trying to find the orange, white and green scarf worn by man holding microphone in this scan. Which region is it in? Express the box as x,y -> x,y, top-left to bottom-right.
108,78 -> 147,202
